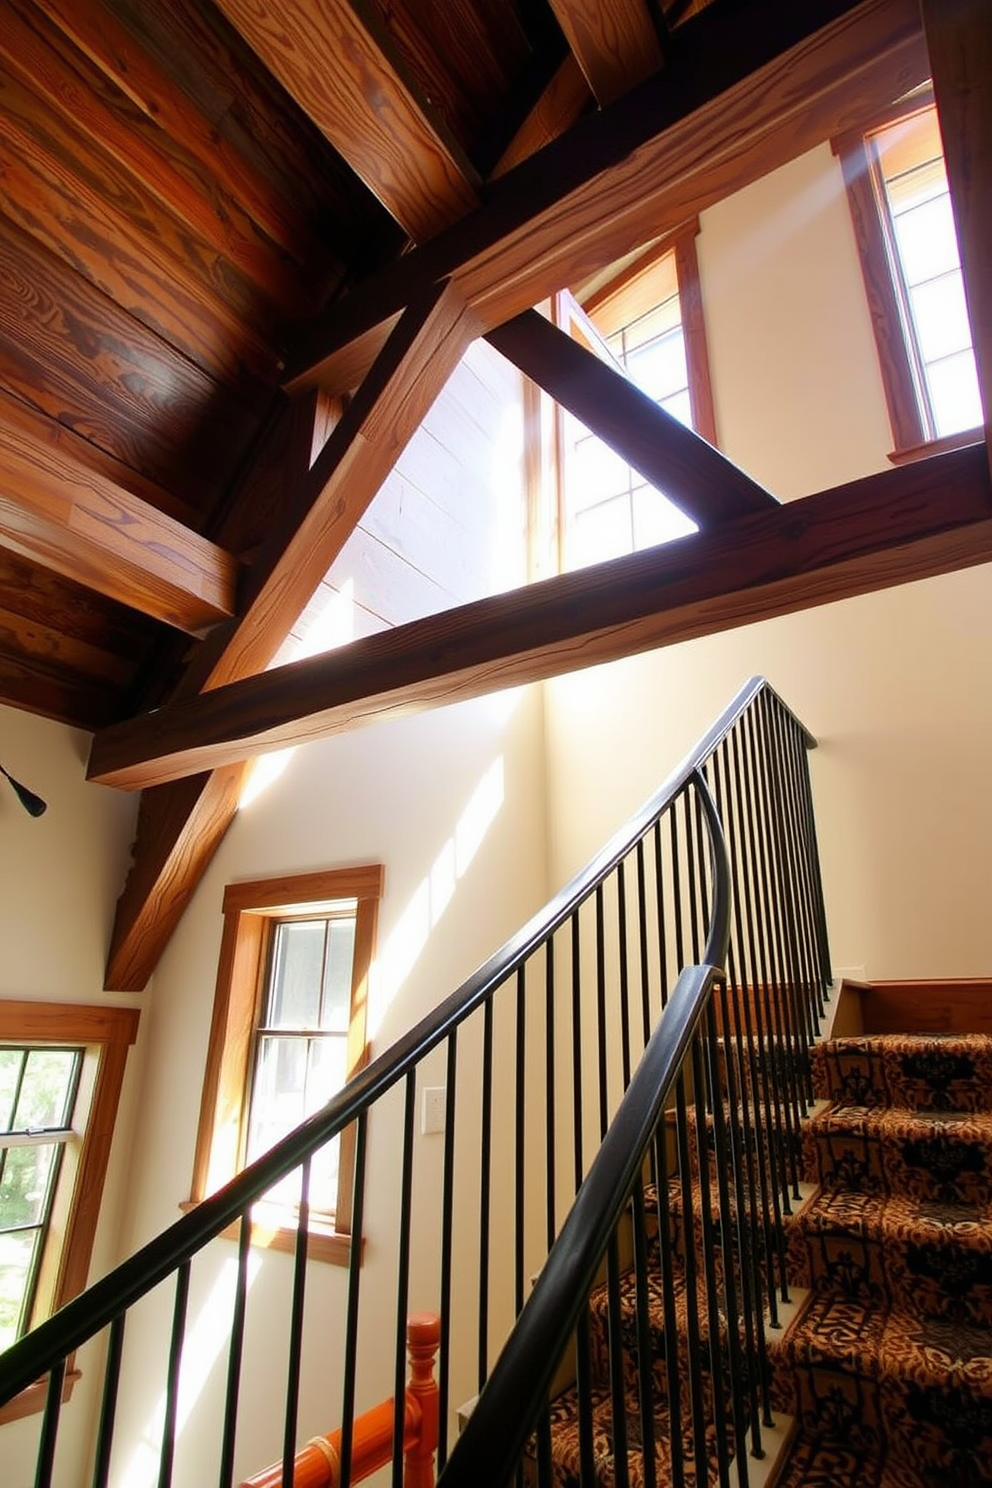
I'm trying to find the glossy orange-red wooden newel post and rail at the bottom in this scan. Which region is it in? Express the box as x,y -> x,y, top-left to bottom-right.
241,1312 -> 440,1488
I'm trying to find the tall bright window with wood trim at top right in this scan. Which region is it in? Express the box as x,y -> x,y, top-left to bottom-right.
833,88 -> 982,460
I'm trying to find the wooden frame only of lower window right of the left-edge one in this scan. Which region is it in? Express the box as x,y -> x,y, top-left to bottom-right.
190,863 -> 384,1265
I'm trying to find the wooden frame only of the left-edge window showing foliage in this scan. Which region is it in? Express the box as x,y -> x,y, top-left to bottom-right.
0,1000 -> 140,1426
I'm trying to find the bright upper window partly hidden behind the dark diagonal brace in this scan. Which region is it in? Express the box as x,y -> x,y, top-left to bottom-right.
553,222 -> 715,568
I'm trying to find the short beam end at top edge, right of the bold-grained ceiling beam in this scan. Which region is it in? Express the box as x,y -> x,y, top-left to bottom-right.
552,0 -> 662,104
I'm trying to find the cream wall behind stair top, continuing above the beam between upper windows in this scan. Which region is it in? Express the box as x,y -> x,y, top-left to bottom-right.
546,146 -> 992,978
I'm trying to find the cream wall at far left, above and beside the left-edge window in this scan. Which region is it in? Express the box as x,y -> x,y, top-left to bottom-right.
0,707 -> 146,1488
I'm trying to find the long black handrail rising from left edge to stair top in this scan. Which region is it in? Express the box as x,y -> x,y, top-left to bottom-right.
0,677 -> 752,1405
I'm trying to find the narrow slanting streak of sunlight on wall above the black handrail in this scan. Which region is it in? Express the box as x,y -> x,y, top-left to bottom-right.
376,754 -> 506,1037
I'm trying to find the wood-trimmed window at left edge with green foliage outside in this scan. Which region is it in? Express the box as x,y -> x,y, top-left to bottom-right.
0,1001 -> 138,1423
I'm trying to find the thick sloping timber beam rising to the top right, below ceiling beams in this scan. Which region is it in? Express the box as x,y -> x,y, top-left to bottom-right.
287,0 -> 930,391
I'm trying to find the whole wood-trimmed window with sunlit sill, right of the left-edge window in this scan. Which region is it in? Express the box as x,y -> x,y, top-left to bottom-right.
190,865 -> 382,1262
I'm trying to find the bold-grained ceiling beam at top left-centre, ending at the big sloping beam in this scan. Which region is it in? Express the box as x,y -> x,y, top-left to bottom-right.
219,0 -> 477,243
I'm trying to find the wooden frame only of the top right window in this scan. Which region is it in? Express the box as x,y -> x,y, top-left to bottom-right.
830,86 -> 980,464
